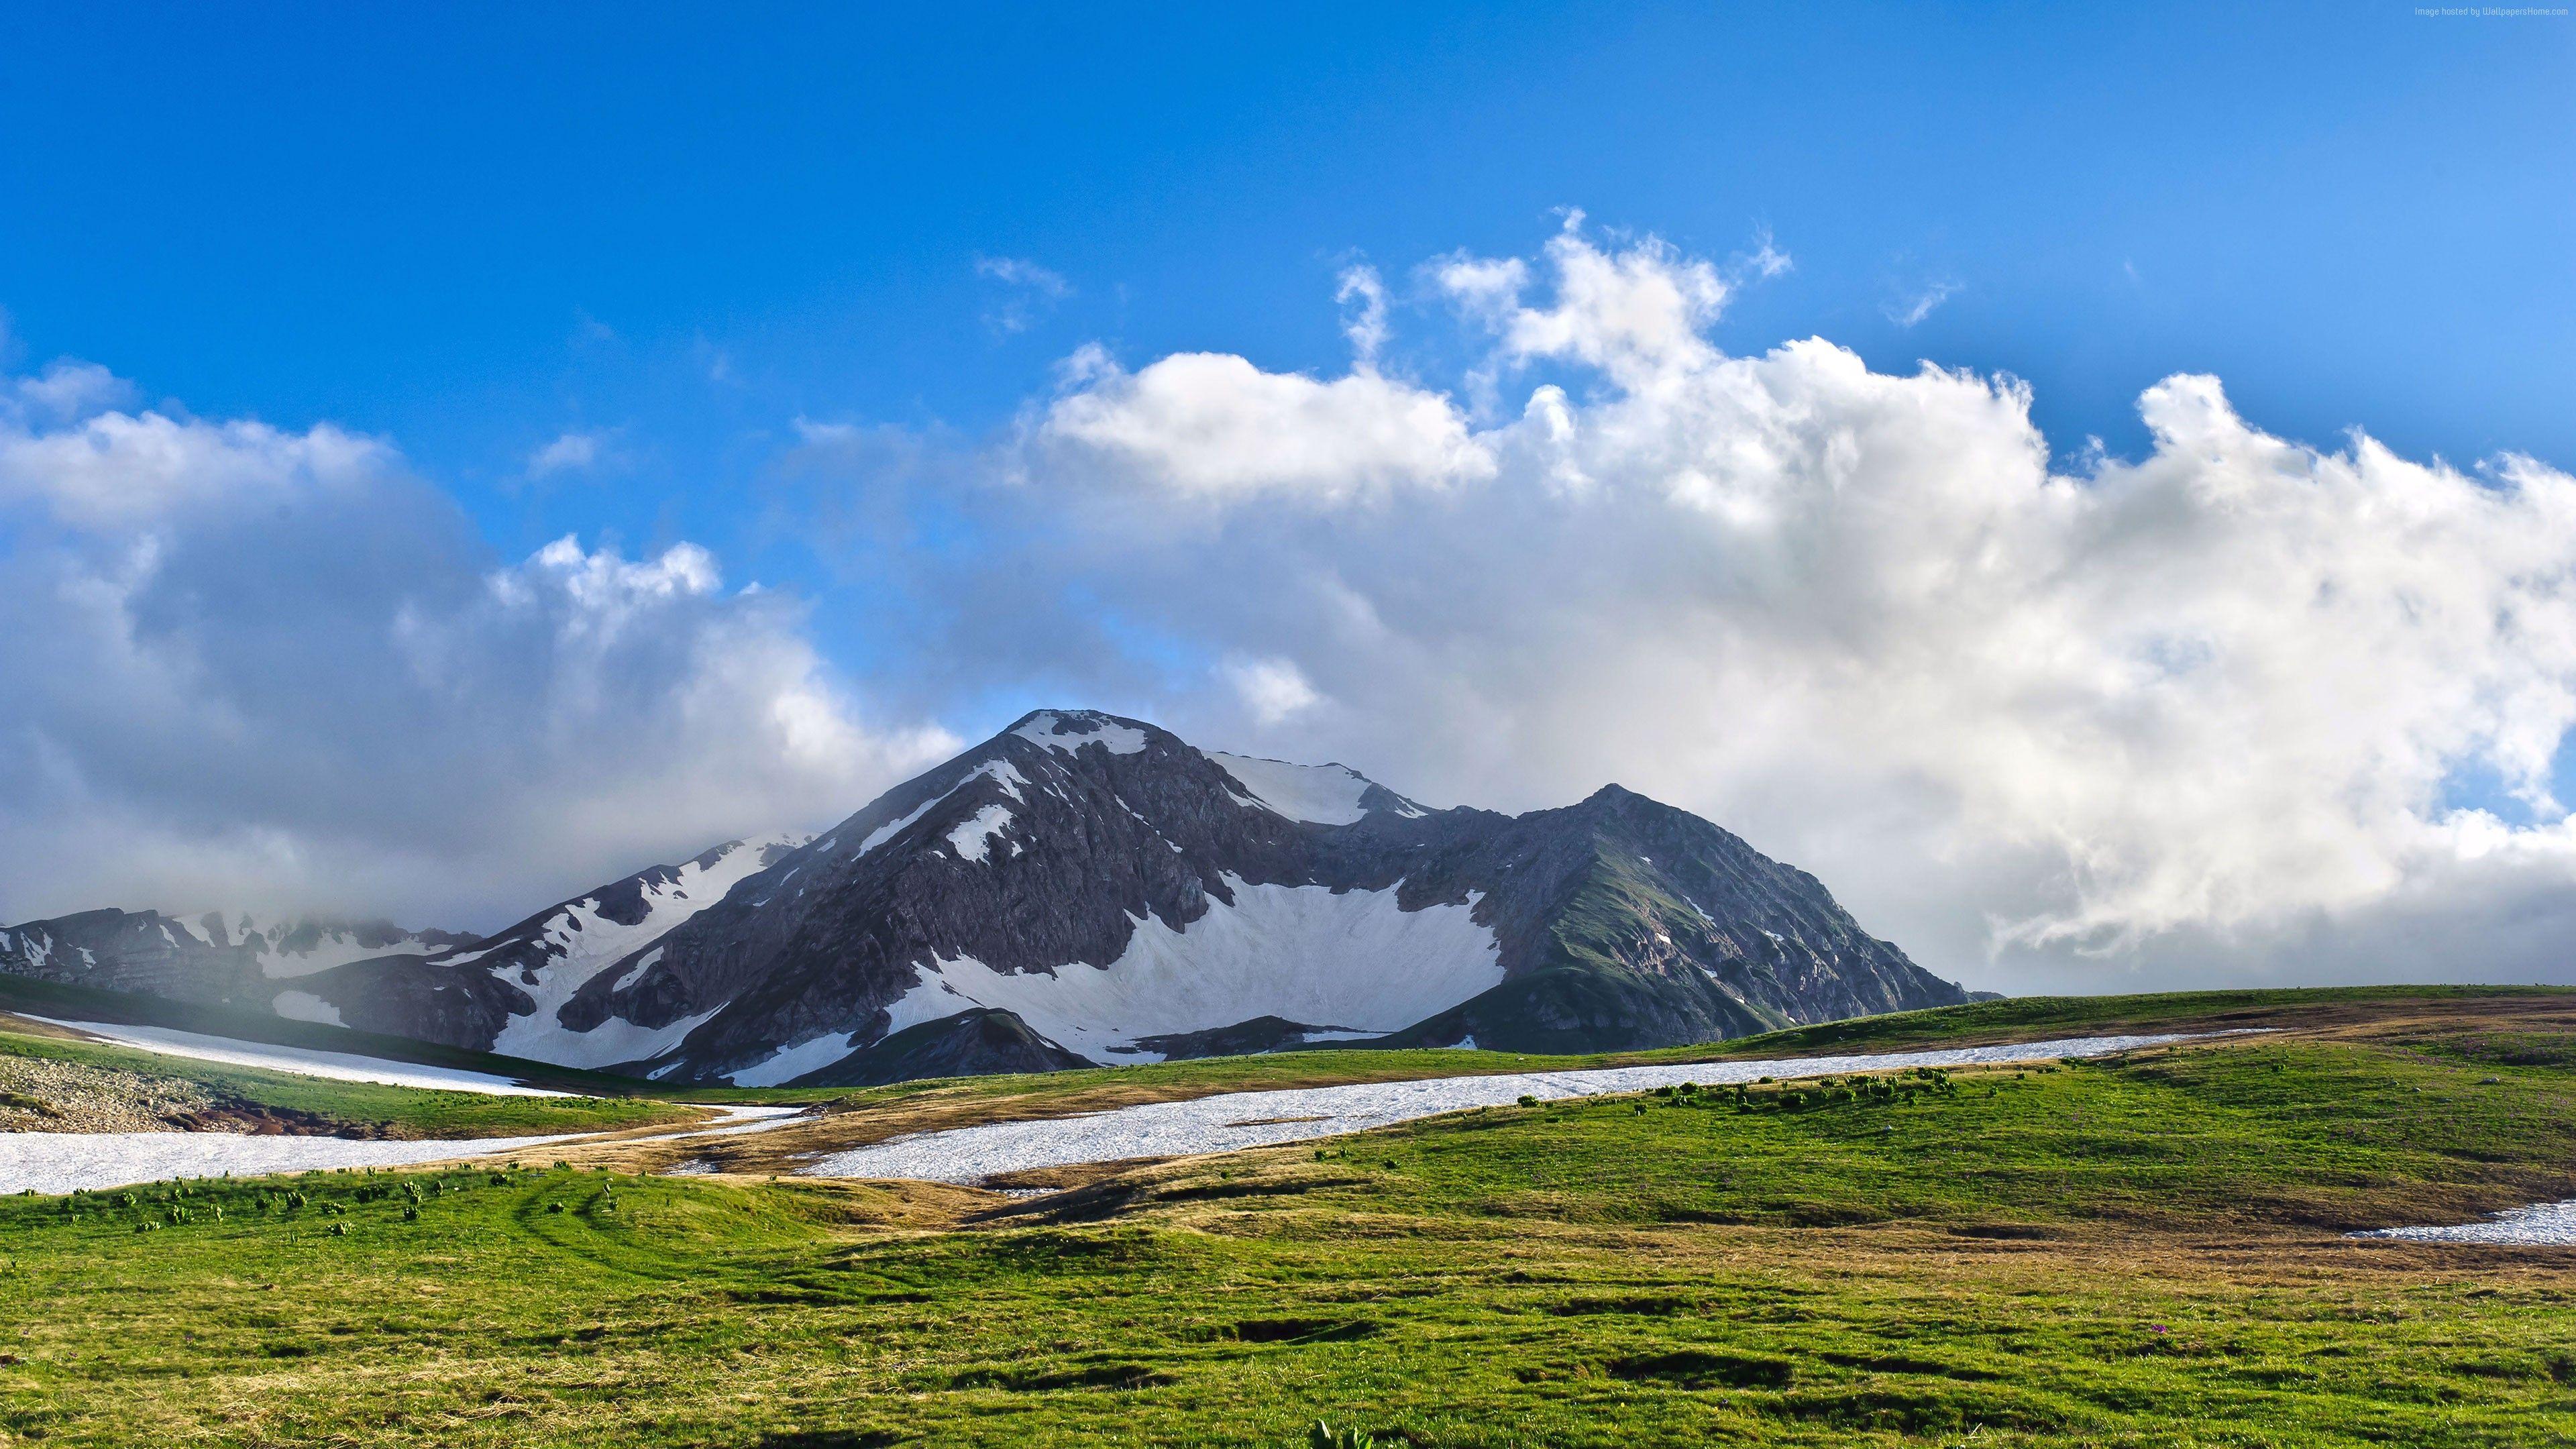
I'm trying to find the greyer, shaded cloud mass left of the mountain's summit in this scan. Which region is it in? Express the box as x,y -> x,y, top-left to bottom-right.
0,374 -> 953,926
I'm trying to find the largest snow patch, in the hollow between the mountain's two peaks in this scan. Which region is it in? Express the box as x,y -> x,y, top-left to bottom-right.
881,877 -> 1502,1062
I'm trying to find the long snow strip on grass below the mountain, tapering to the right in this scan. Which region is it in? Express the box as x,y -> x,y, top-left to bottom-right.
798,1031 -> 2205,1183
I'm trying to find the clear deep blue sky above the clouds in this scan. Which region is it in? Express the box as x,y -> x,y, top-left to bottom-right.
0,5 -> 2576,570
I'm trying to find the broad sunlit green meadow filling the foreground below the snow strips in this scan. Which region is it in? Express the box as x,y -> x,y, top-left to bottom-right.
0,974 -> 2576,1449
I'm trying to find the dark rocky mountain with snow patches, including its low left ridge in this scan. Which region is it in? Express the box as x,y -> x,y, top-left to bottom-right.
0,712 -> 1966,1085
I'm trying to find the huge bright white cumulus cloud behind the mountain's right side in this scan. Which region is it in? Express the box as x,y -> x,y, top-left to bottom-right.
860,222 -> 2576,985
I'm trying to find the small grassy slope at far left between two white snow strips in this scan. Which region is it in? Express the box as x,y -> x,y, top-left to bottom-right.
0,1026 -> 693,1137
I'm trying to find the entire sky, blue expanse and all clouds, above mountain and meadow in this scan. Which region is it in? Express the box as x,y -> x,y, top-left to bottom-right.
0,3 -> 2576,985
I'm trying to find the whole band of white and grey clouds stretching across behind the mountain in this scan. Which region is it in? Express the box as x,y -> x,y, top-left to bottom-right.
0,217 -> 2576,990
